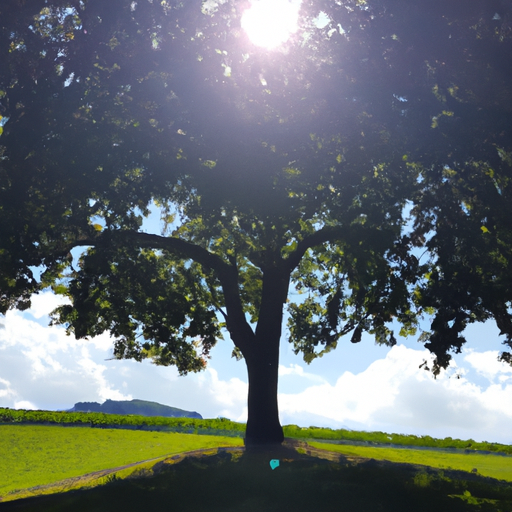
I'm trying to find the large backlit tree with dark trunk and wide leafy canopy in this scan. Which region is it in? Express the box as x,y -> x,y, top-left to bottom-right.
0,0 -> 512,446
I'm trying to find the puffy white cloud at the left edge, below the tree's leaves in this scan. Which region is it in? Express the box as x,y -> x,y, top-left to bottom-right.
0,304 -> 129,409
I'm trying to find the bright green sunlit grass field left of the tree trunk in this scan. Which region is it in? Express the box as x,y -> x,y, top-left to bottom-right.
0,425 -> 243,497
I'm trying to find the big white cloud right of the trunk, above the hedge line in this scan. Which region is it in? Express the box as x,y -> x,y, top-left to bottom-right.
279,345 -> 512,443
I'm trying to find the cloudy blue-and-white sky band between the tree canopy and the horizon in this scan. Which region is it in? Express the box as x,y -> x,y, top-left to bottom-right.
0,292 -> 512,444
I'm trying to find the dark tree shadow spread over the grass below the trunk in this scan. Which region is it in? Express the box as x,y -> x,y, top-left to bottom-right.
0,447 -> 512,512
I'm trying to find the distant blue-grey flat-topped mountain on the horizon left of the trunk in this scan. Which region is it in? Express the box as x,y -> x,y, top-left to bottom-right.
67,400 -> 203,420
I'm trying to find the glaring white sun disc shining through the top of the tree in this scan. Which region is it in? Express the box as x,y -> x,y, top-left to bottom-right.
241,0 -> 299,49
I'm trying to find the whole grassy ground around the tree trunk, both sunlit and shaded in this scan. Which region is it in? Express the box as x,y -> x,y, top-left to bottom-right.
0,409 -> 512,512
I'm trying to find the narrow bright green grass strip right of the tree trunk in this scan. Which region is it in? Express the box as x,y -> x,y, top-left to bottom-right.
309,442 -> 512,482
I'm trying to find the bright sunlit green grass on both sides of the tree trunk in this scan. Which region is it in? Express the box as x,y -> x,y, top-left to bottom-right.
7,425 -> 512,508
